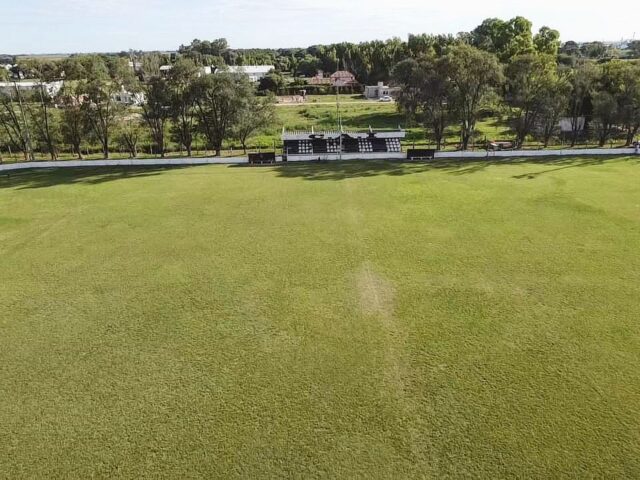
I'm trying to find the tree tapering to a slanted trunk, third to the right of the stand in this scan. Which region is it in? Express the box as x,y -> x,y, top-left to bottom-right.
505,54 -> 557,148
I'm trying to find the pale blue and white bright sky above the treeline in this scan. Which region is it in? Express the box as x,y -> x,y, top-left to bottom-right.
0,0 -> 640,54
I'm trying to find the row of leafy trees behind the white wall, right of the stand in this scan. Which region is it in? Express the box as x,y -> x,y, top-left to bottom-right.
392,42 -> 640,149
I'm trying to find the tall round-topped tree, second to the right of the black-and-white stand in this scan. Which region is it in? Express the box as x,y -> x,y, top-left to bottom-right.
443,44 -> 503,150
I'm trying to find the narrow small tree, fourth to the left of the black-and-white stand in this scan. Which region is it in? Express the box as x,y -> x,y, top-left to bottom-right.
142,77 -> 172,158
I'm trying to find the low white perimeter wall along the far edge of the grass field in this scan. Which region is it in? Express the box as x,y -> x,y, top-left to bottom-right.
0,147 -> 640,172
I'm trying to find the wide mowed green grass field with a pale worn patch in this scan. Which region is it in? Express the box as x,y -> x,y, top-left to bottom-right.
0,158 -> 640,479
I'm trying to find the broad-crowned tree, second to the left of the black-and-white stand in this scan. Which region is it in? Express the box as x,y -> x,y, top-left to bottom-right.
194,73 -> 253,156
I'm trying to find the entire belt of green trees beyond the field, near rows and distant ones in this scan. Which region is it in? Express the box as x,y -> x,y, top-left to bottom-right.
0,17 -> 640,159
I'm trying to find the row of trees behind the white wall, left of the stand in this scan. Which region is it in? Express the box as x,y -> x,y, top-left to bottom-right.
0,57 -> 274,160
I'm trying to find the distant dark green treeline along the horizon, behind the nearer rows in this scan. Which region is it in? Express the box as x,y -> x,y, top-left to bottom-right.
179,17 -> 640,84
